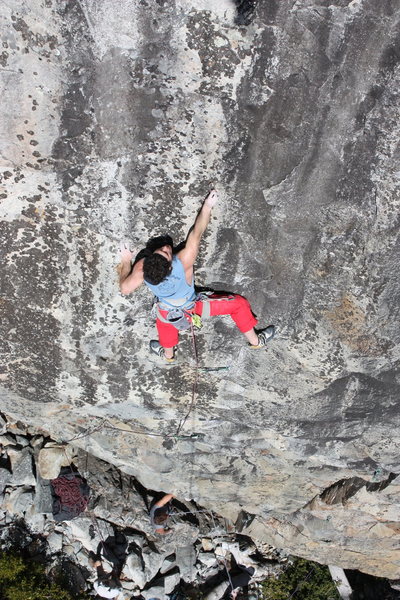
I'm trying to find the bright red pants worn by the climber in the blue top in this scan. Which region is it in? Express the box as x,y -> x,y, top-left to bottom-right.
156,294 -> 257,348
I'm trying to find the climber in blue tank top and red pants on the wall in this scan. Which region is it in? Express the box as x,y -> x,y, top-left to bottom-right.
119,190 -> 275,363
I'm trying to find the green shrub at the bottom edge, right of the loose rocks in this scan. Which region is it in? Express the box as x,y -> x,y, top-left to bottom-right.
262,558 -> 340,600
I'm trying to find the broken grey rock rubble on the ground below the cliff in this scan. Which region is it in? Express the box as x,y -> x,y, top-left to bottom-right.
0,419 -> 287,600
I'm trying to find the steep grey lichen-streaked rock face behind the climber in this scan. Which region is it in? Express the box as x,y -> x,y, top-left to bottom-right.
0,0 -> 400,578
